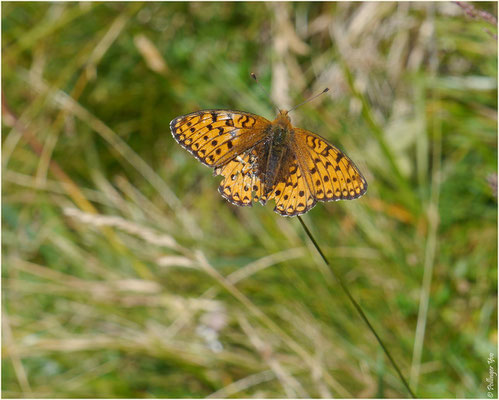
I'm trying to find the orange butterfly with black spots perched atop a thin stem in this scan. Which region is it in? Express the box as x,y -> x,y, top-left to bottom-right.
170,104 -> 367,216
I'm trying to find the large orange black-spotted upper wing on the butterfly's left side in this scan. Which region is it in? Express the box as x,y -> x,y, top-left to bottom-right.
170,110 -> 271,167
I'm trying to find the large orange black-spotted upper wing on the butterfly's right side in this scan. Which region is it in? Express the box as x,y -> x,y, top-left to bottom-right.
292,128 -> 367,205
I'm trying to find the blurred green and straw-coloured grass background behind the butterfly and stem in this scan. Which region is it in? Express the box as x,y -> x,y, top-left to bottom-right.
2,2 -> 497,398
